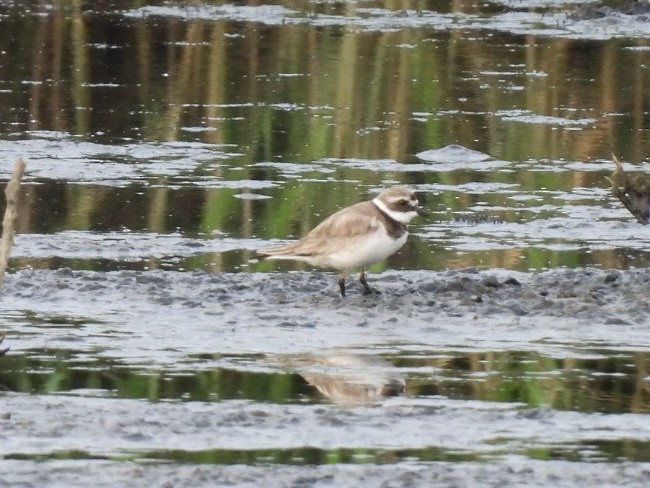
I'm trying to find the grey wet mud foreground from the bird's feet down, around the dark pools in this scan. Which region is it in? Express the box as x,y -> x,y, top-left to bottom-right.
0,269 -> 650,487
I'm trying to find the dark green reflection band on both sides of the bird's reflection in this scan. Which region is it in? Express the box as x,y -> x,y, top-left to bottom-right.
0,350 -> 650,413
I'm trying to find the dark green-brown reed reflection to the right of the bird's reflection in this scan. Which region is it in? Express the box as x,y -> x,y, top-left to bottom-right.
400,351 -> 650,412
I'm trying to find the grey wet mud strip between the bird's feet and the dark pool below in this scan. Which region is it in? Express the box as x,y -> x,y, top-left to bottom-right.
2,268 -> 650,365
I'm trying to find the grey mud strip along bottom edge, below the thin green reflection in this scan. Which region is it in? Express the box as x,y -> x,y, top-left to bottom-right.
3,459 -> 650,488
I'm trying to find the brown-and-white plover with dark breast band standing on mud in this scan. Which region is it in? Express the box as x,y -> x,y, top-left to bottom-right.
257,186 -> 424,297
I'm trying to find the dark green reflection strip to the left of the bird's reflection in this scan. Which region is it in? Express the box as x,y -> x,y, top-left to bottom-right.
0,350 -> 319,403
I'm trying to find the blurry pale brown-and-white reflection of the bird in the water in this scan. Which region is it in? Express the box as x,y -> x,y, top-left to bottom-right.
300,353 -> 405,404
